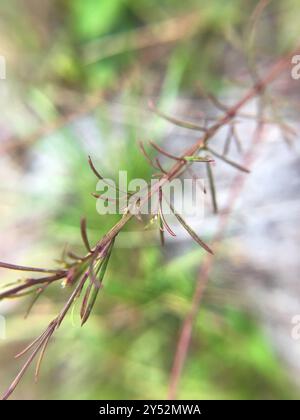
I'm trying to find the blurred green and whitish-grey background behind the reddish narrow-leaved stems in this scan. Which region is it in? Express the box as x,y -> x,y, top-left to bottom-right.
0,0 -> 300,399
